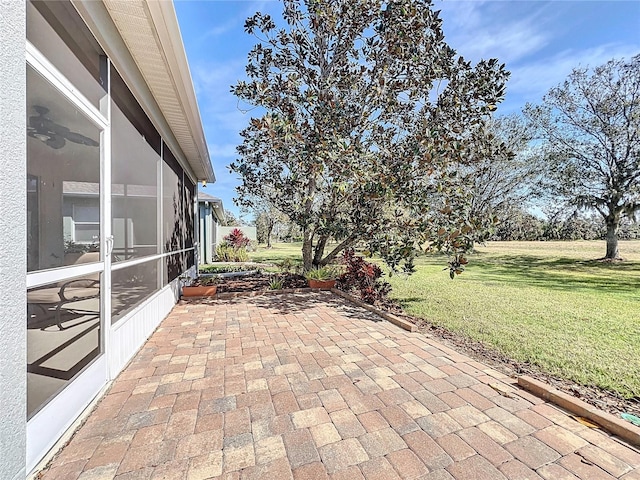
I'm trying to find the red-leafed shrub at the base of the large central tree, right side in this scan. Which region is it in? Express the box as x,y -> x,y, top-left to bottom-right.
336,248 -> 391,305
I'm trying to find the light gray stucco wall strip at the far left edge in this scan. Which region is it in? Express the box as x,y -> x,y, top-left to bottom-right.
0,0 -> 27,480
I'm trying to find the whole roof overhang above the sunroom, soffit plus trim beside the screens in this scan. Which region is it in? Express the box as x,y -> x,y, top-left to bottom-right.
72,0 -> 215,182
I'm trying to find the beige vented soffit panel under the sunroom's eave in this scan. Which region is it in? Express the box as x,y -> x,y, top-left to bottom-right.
103,0 -> 215,181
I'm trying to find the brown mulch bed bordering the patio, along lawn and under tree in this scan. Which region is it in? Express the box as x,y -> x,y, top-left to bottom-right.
212,273 -> 640,416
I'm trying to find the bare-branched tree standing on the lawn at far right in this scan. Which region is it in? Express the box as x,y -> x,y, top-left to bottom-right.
525,55 -> 640,259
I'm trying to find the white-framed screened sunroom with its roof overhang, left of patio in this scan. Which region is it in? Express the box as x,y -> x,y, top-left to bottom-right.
0,0 -> 215,478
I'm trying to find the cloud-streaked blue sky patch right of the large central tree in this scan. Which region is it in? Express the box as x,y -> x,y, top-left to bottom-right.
436,0 -> 640,113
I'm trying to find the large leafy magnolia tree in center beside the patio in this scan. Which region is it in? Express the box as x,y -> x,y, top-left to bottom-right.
230,0 -> 508,272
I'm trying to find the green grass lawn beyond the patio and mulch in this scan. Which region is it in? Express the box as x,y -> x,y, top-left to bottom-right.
252,241 -> 640,398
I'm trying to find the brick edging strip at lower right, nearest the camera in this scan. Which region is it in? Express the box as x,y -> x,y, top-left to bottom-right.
518,375 -> 640,447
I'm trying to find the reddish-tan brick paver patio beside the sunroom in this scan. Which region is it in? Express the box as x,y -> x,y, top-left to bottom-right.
42,293 -> 640,480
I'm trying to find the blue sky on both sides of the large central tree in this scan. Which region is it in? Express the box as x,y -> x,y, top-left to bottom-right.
175,0 -> 640,215
